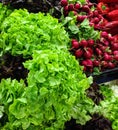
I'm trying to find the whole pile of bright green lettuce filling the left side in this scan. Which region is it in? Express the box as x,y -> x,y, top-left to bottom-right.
0,1 -> 94,130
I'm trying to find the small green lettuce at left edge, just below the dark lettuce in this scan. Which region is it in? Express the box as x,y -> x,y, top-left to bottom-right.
0,79 -> 25,105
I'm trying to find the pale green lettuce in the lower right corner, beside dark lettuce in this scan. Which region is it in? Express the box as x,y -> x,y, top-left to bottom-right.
95,85 -> 118,130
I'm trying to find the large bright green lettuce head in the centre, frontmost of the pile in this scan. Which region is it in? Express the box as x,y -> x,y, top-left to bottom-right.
24,50 -> 92,129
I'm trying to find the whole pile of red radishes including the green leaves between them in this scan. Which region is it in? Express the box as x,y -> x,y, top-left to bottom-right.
61,0 -> 118,74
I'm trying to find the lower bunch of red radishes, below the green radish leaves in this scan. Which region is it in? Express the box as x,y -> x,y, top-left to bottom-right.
71,31 -> 118,72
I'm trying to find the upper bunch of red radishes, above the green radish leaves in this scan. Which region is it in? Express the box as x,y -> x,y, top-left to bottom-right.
61,0 -> 106,30
